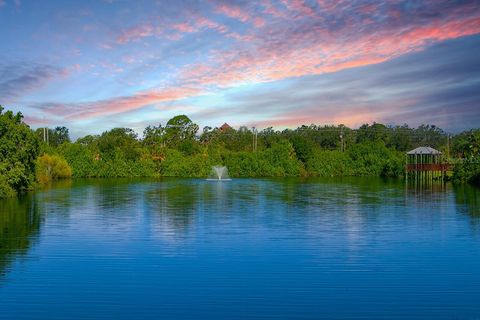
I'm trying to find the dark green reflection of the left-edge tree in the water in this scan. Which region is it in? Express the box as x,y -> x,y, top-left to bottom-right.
0,195 -> 41,275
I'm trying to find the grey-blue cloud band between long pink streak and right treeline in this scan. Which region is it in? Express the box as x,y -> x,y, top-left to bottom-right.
192,36 -> 480,131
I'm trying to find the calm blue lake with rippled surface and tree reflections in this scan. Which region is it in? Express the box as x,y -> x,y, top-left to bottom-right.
0,178 -> 480,319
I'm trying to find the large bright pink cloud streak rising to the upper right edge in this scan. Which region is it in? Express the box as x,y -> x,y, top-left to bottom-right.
181,6 -> 480,87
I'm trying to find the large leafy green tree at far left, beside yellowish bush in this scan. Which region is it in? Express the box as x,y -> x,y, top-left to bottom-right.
0,106 -> 39,197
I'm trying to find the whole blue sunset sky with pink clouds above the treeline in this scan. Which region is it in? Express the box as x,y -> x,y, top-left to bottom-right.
0,0 -> 480,137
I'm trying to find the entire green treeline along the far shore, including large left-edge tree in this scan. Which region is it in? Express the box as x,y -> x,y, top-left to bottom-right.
0,109 -> 480,195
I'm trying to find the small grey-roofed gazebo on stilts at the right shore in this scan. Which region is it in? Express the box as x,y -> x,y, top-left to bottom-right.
405,147 -> 449,180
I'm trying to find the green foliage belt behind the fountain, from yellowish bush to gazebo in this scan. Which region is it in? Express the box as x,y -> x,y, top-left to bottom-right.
50,115 -> 447,177
